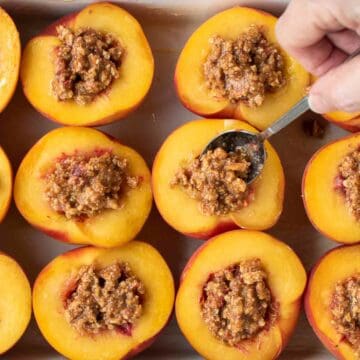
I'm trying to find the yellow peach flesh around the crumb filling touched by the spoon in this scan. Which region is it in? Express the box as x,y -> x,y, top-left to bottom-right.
152,119 -> 285,239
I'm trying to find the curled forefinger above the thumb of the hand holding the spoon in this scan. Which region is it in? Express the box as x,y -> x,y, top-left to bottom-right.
276,0 -> 360,72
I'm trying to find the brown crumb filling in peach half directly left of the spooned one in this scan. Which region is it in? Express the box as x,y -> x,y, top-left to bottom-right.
45,152 -> 140,219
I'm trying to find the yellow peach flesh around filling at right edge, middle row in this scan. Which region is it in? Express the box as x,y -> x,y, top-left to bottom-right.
302,134 -> 360,243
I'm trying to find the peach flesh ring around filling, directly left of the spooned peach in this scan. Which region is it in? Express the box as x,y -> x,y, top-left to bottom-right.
14,127 -> 152,247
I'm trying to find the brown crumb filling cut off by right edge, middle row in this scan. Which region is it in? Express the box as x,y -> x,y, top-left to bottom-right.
339,147 -> 360,221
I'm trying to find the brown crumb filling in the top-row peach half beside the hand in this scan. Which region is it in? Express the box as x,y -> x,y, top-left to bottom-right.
203,25 -> 285,107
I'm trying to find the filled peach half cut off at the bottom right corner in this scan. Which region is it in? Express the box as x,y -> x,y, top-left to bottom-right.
305,245 -> 360,360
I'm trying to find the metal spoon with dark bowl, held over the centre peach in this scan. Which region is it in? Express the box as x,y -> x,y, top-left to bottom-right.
201,48 -> 360,184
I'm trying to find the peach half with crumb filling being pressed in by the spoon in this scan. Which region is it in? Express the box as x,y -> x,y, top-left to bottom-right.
152,119 -> 285,239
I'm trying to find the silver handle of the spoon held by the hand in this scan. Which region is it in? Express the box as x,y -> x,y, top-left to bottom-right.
258,48 -> 360,140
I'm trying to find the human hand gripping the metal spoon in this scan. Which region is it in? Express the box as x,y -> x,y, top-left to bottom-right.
276,0 -> 360,113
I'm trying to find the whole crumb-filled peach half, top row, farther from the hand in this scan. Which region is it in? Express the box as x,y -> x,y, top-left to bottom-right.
21,2 -> 154,126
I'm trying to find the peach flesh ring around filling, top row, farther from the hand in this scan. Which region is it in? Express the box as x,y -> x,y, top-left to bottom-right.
20,2 -> 154,126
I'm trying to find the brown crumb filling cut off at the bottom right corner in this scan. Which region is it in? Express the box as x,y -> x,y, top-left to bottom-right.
330,273 -> 360,359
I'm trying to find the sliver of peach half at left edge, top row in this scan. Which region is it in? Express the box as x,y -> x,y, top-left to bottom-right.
0,7 -> 21,112
